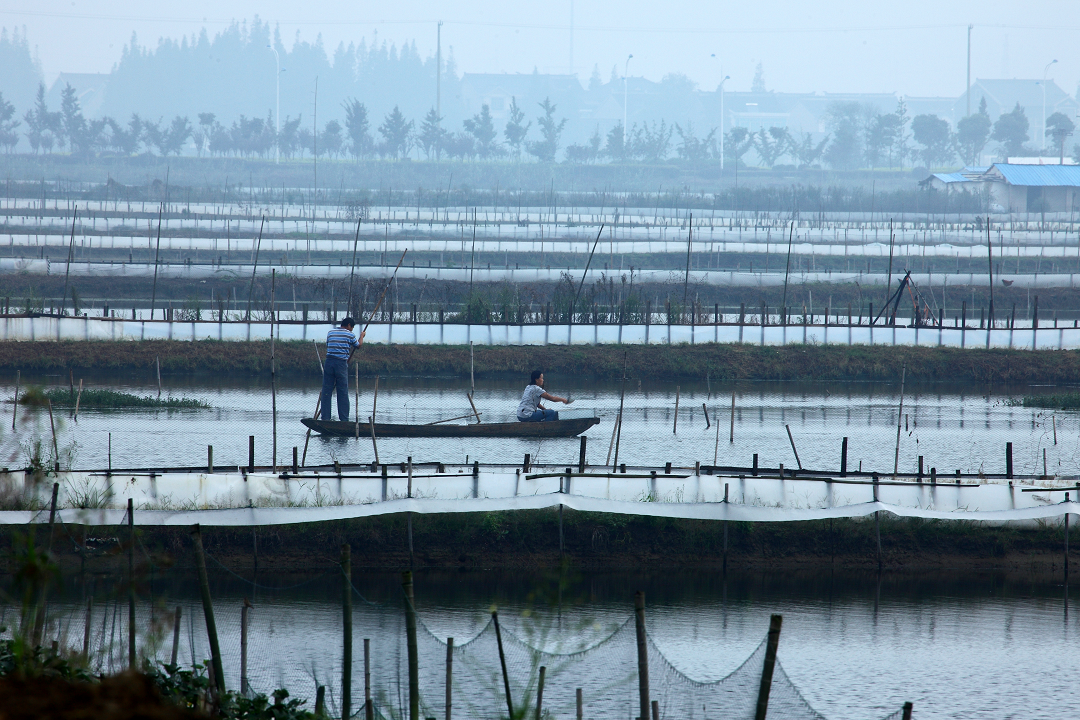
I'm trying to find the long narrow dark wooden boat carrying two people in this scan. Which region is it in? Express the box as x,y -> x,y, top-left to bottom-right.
300,418 -> 600,438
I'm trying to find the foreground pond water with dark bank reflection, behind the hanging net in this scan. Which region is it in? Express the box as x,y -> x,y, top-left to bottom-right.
5,570 -> 1080,720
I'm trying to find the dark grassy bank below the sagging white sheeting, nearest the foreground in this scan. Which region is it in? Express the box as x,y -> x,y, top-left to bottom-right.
12,511 -> 1063,572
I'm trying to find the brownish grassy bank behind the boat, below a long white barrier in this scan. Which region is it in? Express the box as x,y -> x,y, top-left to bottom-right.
0,340 -> 1080,383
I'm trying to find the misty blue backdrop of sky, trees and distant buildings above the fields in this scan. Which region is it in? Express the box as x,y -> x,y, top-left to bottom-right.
0,0 -> 1080,177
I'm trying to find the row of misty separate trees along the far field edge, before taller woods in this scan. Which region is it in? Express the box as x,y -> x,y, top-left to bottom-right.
0,84 -> 1080,169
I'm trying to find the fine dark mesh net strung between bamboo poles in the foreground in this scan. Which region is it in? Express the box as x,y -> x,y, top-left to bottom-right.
19,573 -> 900,720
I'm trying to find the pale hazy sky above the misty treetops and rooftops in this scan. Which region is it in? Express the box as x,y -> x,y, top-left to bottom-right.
0,0 -> 1080,96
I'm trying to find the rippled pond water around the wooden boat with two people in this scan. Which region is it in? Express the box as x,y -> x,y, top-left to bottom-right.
0,372 -> 1080,475
